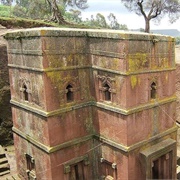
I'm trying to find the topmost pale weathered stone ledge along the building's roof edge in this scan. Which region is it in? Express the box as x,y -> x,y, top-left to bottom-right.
4,27 -> 175,42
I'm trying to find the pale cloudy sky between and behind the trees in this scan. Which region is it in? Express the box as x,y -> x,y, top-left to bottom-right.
81,0 -> 180,31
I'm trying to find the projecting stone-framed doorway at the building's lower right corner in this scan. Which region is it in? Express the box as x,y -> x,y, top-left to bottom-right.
140,138 -> 177,179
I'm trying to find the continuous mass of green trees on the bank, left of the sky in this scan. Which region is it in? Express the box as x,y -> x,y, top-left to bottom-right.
1,0 -> 128,30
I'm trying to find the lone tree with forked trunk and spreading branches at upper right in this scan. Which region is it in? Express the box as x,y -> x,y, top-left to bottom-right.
121,0 -> 180,33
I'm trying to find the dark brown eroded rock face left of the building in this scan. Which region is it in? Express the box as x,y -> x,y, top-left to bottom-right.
0,44 -> 13,145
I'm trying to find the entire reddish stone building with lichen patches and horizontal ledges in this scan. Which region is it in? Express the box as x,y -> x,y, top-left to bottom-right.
6,28 -> 177,180
